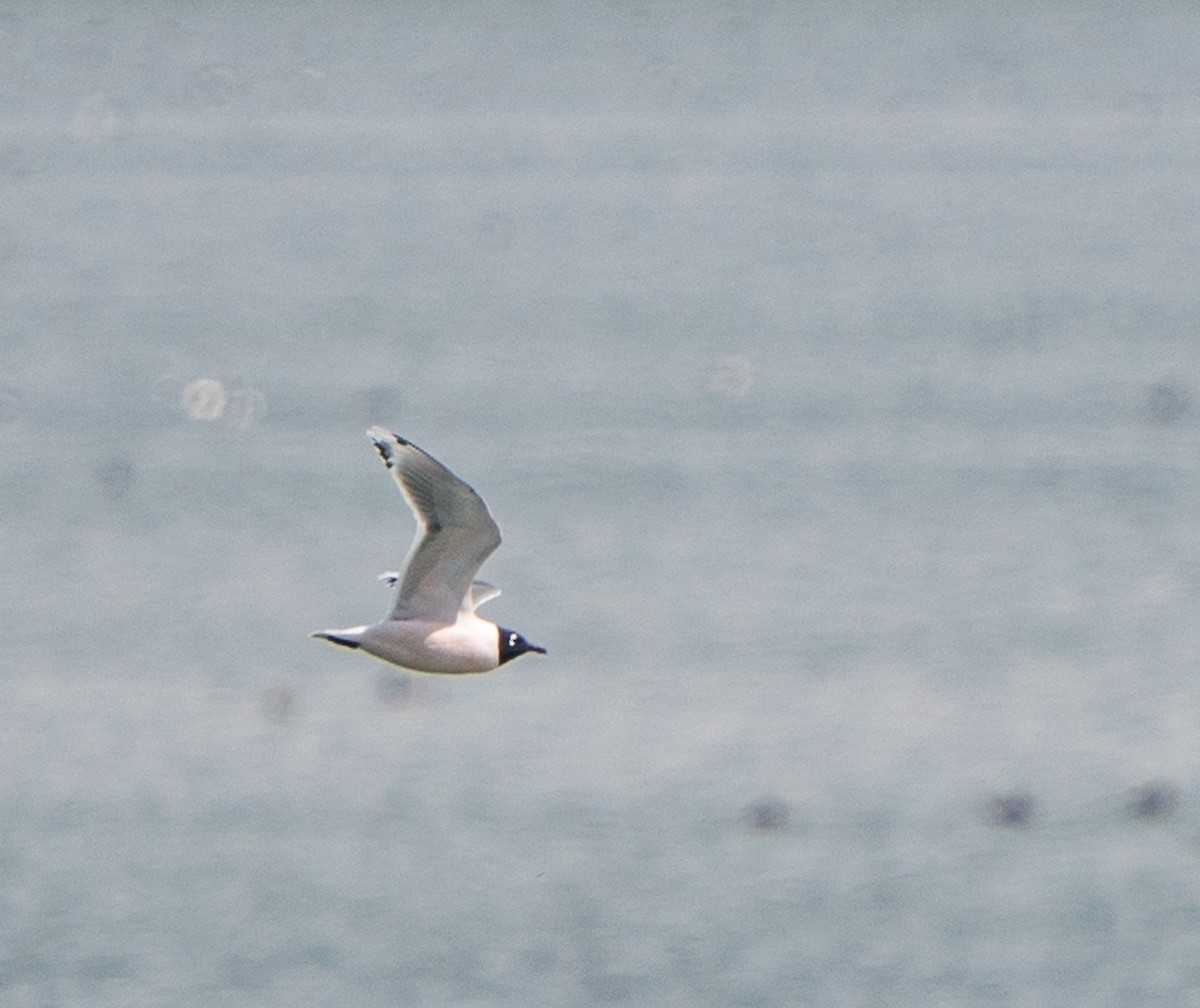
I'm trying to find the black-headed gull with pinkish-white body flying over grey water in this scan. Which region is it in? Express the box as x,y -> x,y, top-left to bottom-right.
310,427 -> 546,674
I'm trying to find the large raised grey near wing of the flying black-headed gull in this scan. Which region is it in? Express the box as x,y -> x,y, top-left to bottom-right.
367,427 -> 500,623
